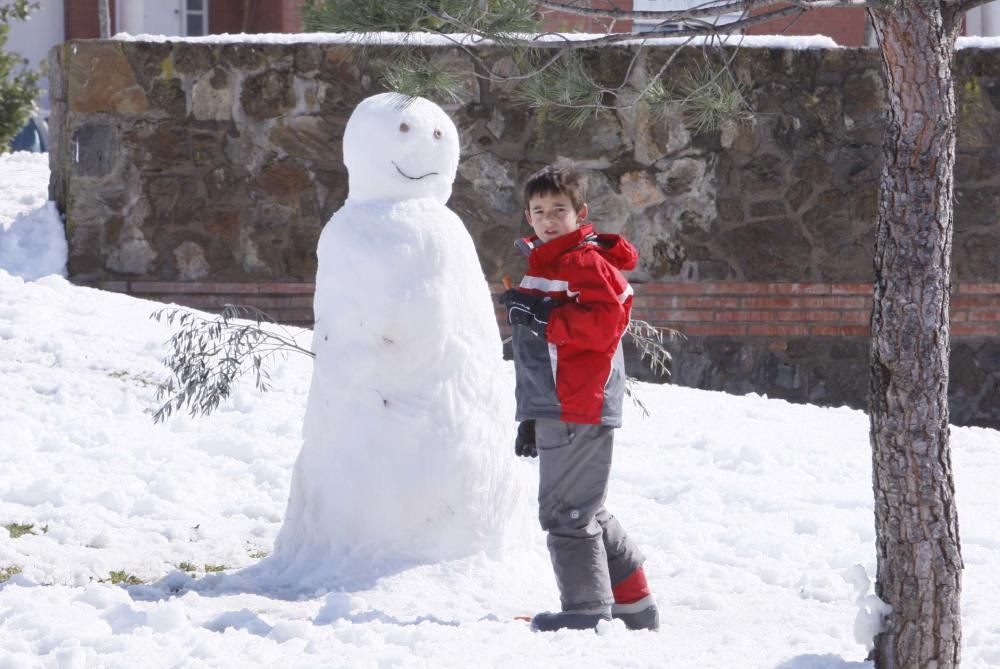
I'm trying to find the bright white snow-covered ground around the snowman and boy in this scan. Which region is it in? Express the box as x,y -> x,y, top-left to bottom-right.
0,154 -> 1000,669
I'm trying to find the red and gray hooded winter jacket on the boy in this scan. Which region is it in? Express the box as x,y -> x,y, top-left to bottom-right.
513,224 -> 638,427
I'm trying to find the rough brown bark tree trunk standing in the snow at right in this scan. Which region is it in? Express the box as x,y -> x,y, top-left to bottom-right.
869,0 -> 962,669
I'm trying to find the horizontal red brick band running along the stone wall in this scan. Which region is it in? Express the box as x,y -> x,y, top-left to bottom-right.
82,281 -> 1000,338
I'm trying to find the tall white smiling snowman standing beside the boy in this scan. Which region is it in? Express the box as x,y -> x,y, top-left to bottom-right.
266,93 -> 530,570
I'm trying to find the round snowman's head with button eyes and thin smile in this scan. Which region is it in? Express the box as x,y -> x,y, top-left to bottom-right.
344,93 -> 459,204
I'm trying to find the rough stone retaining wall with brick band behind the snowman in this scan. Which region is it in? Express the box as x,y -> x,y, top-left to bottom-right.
50,41 -> 1000,426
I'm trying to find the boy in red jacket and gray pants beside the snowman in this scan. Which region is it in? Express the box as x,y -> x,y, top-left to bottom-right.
500,166 -> 659,631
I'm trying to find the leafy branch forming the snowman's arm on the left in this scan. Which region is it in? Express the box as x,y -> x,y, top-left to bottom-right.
150,304 -> 313,423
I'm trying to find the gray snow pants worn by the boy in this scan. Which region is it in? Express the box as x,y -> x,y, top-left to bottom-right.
535,418 -> 645,611
